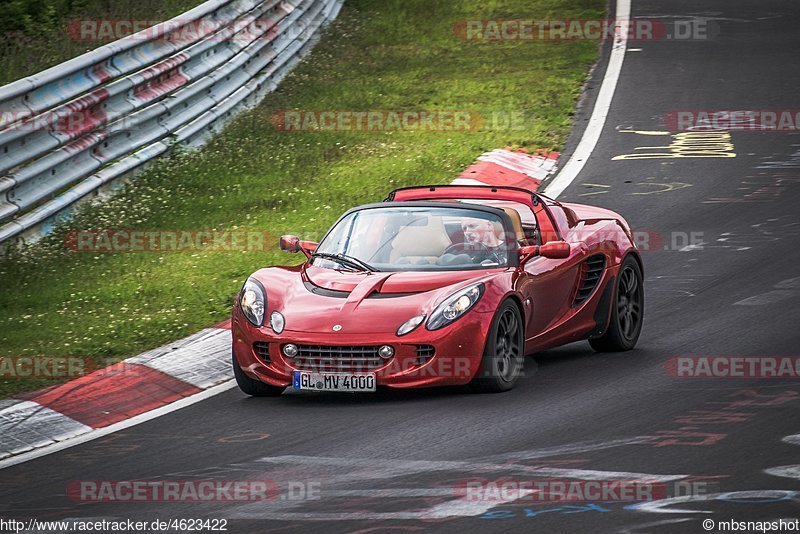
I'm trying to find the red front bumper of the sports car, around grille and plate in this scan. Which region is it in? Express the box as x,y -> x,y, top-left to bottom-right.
231,309 -> 492,388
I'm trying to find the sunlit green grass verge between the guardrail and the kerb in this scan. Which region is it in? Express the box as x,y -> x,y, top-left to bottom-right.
0,0 -> 603,396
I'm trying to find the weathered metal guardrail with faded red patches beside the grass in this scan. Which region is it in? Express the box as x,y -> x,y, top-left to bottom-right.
0,0 -> 344,243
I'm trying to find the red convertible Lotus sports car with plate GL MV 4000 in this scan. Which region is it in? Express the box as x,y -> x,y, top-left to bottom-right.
232,185 -> 644,396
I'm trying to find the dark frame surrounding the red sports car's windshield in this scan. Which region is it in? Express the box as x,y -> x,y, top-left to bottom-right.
308,199 -> 519,272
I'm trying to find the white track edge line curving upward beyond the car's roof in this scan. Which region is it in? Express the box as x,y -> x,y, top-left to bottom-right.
544,0 -> 631,198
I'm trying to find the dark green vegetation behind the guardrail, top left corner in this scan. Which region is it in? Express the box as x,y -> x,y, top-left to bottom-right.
0,0 -> 203,85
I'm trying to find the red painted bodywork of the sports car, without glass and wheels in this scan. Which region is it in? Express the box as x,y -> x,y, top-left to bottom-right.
232,186 -> 641,387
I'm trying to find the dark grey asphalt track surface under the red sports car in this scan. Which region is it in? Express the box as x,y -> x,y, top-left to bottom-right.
0,0 -> 800,533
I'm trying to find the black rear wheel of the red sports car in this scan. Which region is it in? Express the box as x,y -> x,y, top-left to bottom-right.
589,256 -> 644,352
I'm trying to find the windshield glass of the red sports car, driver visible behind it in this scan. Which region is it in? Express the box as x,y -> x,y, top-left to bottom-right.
312,206 -> 516,271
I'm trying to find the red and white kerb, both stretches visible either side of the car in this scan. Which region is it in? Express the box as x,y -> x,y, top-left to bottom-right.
0,149 -> 558,469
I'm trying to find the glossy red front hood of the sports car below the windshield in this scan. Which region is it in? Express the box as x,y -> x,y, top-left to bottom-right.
253,264 -> 506,334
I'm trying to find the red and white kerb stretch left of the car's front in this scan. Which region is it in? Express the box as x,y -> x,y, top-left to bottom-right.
0,323 -> 231,467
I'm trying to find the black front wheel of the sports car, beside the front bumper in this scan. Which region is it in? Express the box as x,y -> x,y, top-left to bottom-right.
469,300 -> 525,393
